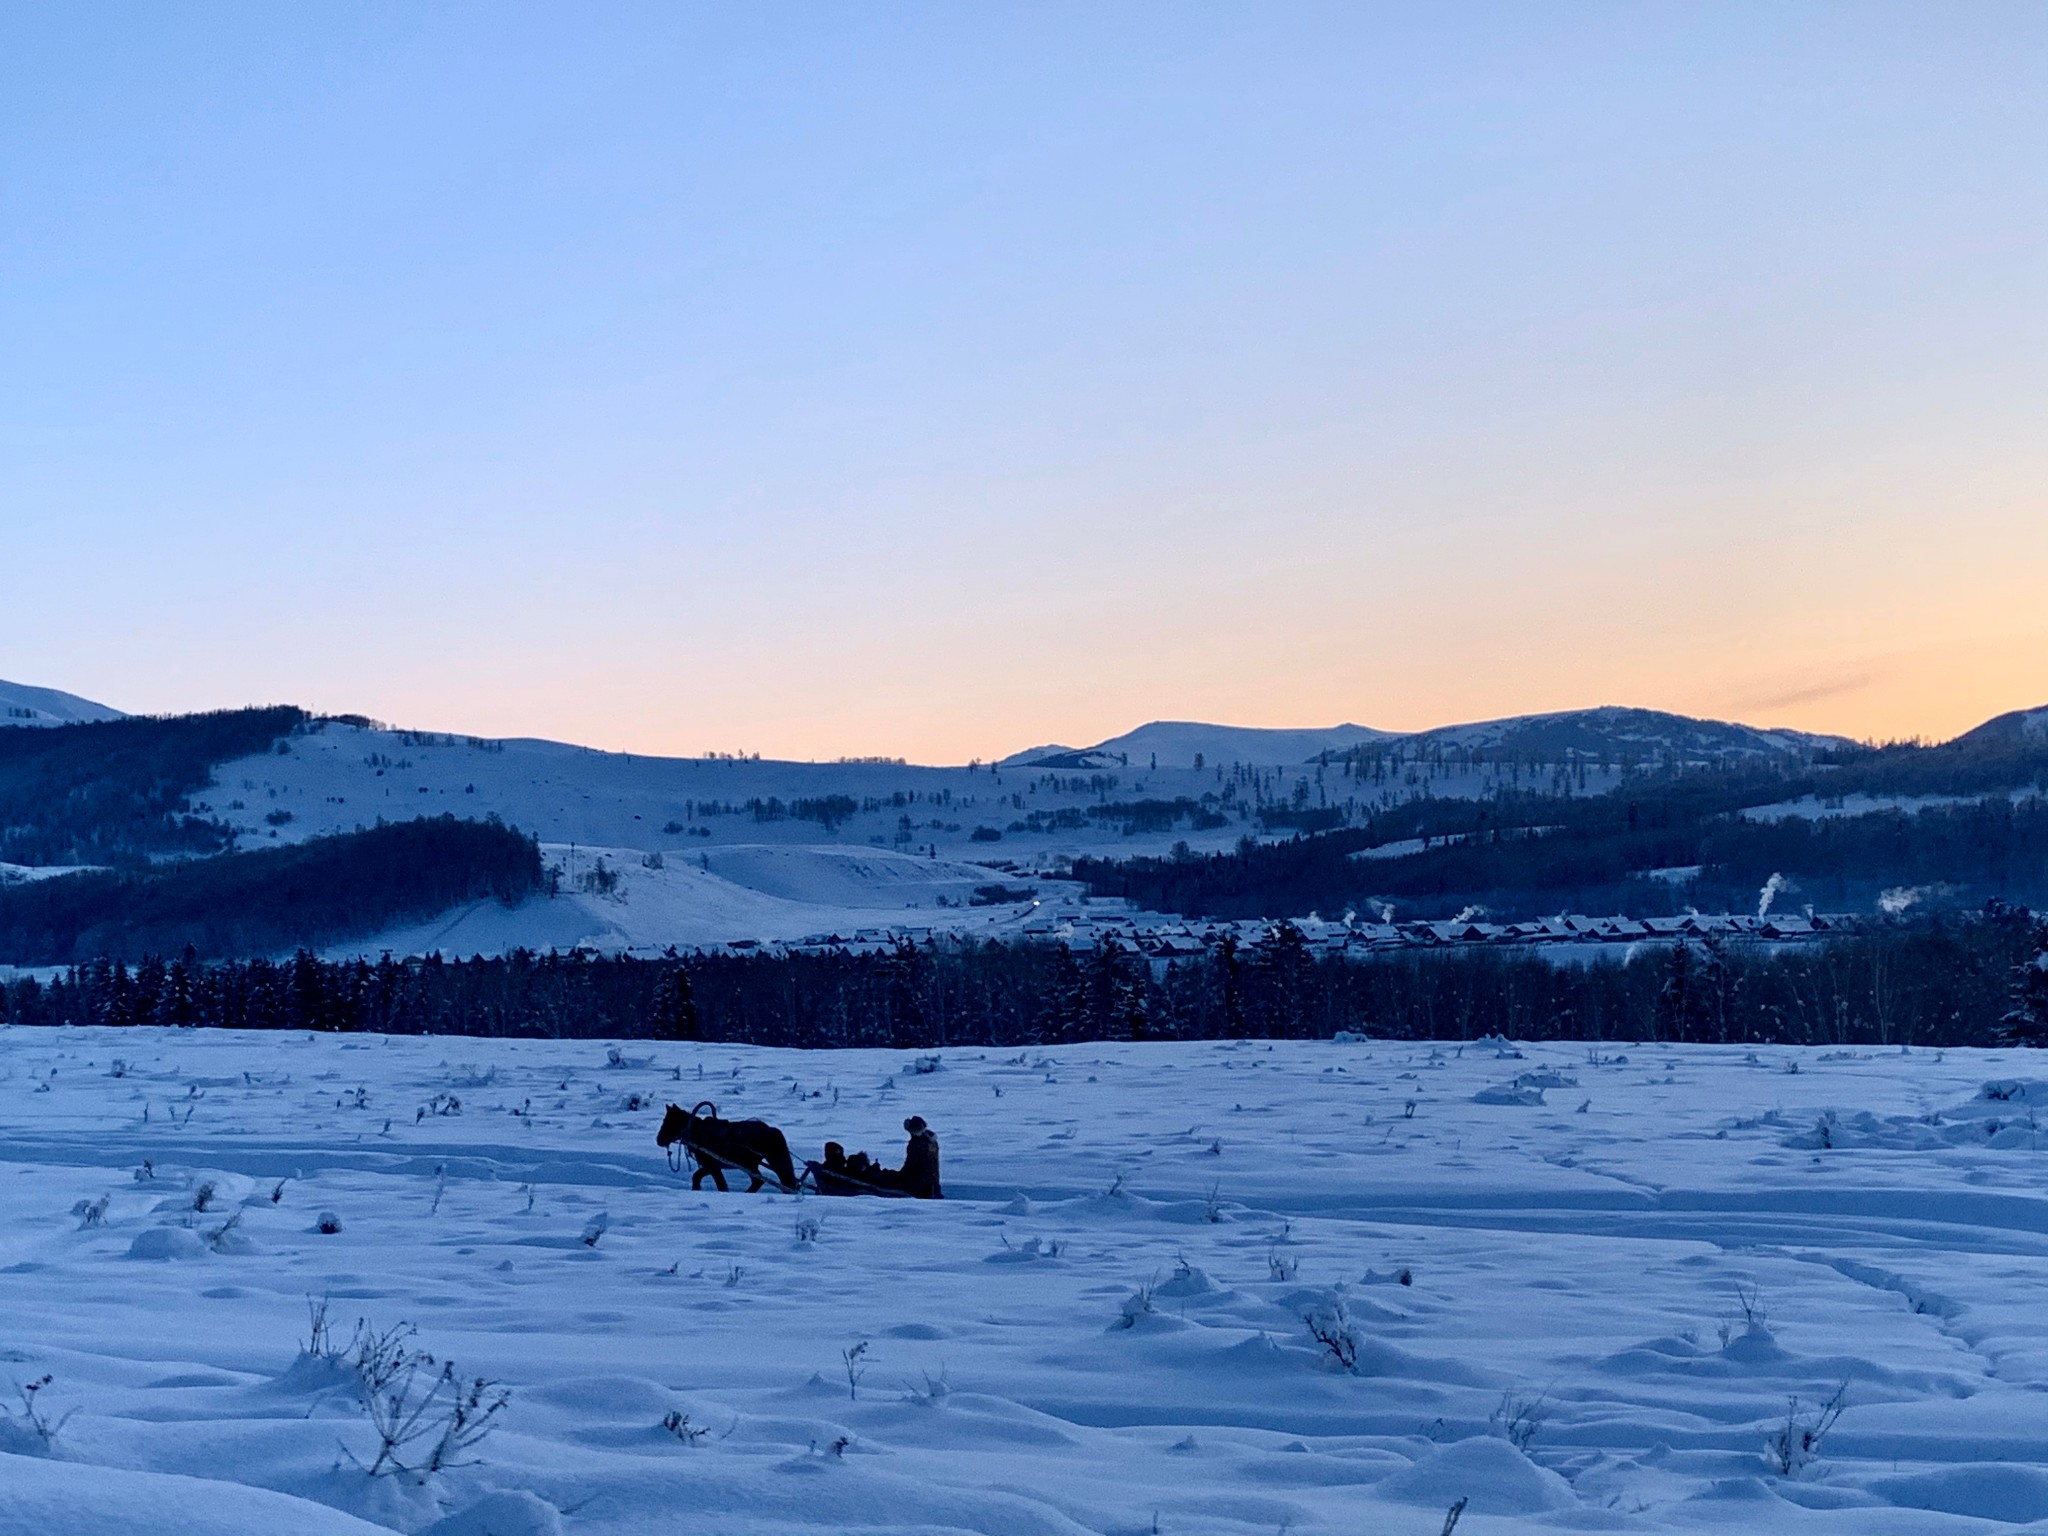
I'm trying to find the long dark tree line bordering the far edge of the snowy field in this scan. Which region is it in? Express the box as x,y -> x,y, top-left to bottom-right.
0,907 -> 2048,1051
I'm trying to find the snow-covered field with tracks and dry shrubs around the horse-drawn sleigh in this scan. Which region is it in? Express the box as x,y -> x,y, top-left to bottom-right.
0,1028 -> 2048,1536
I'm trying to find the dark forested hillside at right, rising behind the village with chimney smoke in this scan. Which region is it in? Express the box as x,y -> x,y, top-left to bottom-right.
1073,733 -> 2048,918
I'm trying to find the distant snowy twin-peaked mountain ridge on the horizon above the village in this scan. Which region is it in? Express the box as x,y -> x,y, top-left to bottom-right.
1004,705 -> 1859,768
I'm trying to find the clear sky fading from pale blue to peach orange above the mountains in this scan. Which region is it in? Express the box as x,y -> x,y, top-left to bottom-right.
0,0 -> 2048,760
